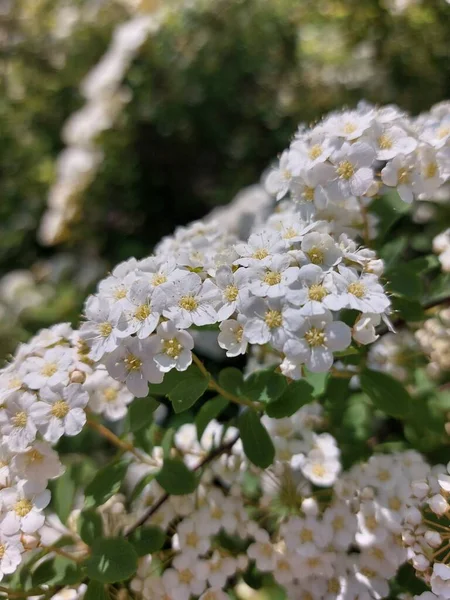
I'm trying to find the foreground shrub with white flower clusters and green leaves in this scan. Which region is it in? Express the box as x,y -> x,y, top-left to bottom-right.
0,103 -> 450,600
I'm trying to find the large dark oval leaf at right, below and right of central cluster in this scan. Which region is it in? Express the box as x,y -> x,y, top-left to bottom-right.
360,369 -> 413,419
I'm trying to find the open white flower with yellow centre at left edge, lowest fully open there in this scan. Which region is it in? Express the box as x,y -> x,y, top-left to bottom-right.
0,488 -> 50,535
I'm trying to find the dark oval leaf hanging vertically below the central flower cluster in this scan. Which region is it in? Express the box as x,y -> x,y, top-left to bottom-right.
238,410 -> 275,469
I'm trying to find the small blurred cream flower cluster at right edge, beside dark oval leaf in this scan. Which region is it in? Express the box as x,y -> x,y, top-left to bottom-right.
416,308 -> 450,378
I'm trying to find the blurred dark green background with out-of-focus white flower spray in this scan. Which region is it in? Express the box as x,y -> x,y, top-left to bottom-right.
0,0 -> 450,359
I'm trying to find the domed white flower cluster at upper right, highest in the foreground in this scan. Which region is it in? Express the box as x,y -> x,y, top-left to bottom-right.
266,102 -> 450,234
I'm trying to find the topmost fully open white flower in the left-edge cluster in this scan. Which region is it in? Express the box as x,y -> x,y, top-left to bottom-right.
23,346 -> 73,390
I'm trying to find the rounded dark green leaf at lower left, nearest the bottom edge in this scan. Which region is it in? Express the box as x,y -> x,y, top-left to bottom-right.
84,538 -> 138,583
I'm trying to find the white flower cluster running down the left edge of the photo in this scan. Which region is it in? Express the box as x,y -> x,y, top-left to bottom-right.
0,324 -> 132,579
